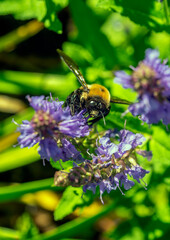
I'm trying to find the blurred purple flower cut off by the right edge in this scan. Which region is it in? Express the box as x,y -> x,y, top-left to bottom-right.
114,49 -> 170,125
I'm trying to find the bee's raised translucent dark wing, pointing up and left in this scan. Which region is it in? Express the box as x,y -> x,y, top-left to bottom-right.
57,49 -> 88,91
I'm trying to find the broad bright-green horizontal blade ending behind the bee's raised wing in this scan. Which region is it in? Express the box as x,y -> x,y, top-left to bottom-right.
0,71 -> 78,95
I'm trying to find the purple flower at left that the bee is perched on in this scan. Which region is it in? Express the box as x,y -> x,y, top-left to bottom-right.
17,96 -> 89,163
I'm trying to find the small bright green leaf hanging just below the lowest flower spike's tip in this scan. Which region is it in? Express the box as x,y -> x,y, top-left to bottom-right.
54,186 -> 91,221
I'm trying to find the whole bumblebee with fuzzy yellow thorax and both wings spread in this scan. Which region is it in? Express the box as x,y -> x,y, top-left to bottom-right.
57,49 -> 131,124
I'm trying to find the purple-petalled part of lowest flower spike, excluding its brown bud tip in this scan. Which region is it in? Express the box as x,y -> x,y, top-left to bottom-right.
83,129 -> 151,203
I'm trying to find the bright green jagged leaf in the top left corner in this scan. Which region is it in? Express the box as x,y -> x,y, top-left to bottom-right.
0,0 -> 68,34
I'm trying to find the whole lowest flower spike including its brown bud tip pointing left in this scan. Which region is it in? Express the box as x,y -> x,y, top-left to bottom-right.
54,130 -> 152,202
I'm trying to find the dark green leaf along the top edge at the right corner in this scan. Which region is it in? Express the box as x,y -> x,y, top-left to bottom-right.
97,0 -> 170,32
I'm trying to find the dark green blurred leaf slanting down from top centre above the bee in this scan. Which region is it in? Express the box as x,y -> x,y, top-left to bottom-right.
69,0 -> 117,69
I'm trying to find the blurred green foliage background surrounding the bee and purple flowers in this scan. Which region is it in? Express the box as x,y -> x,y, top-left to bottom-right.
0,0 -> 170,240
